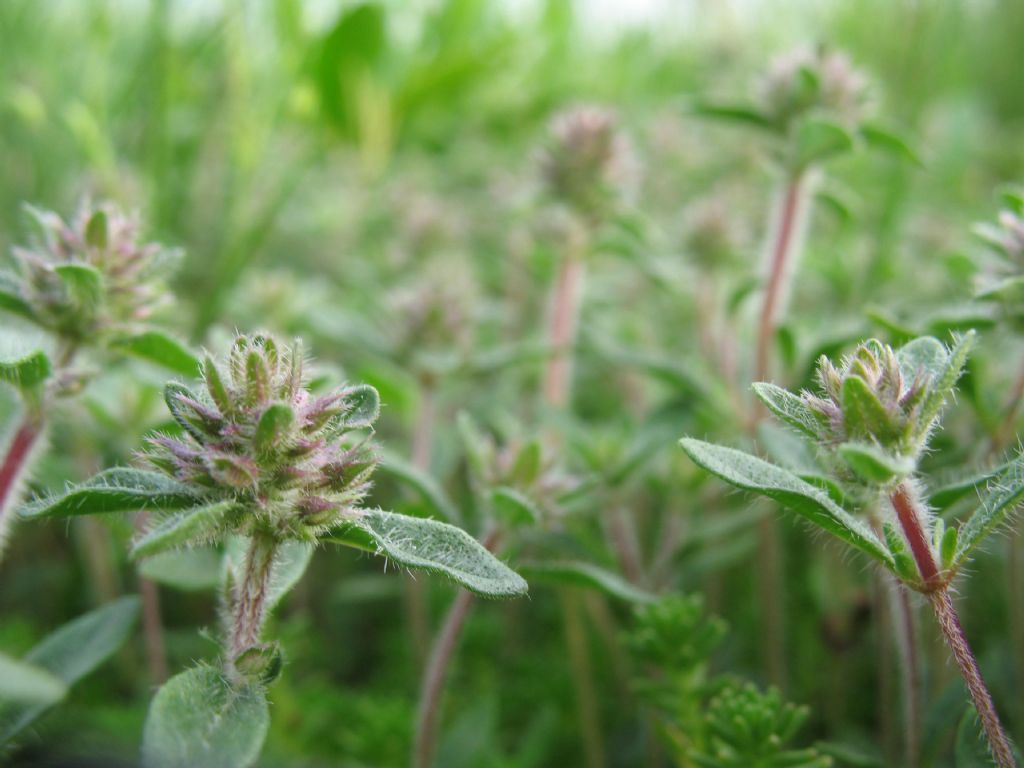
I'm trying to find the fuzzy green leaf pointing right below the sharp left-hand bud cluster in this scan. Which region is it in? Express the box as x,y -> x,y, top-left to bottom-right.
327,509 -> 528,597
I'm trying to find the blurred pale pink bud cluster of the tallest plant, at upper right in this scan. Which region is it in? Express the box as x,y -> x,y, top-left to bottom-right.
758,48 -> 867,130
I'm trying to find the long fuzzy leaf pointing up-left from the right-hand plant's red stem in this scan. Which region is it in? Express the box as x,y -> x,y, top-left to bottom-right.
680,437 -> 893,568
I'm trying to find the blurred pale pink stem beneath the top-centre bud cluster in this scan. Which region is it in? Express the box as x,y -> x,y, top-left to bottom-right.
544,233 -> 584,408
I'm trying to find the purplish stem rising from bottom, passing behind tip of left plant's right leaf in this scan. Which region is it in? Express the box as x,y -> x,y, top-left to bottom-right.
413,530 -> 501,768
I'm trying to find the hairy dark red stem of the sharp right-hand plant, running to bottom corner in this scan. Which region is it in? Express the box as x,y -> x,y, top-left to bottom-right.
890,482 -> 1017,768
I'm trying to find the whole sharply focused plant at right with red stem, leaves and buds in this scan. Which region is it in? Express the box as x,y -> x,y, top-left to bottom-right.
682,333 -> 1024,768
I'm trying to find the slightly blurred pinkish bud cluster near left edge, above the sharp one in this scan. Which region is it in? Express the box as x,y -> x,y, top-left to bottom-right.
7,204 -> 177,343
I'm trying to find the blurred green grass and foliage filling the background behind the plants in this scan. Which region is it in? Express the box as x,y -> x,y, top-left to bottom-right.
0,0 -> 1024,768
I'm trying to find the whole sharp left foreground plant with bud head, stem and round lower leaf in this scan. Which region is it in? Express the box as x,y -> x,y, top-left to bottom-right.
22,335 -> 526,767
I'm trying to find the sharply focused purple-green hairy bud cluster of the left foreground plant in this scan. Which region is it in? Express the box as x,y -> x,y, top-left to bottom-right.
144,336 -> 379,540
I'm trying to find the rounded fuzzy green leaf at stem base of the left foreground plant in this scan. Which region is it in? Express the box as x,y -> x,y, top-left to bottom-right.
142,666 -> 270,768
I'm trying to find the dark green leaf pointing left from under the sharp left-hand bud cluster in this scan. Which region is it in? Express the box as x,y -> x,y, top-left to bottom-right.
20,467 -> 202,517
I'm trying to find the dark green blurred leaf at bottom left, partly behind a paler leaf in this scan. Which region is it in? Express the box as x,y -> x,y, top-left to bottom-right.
0,597 -> 138,743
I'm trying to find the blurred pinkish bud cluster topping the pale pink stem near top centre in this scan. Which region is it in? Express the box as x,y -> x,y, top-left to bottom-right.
541,106 -> 632,222
